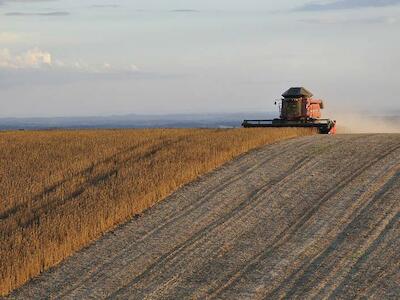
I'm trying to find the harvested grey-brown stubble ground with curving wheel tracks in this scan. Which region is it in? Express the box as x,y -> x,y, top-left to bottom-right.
7,135 -> 400,299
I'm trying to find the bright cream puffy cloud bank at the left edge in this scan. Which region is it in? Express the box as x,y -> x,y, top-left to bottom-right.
0,47 -> 139,74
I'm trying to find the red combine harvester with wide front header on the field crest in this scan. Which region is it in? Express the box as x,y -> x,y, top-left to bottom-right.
242,87 -> 336,134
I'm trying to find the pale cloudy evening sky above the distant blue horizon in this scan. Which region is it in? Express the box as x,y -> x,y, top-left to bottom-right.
0,0 -> 400,117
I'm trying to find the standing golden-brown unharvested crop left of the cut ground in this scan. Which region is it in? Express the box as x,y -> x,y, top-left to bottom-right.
0,129 -> 313,295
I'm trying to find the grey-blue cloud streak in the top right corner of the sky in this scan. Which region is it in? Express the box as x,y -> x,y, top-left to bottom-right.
295,0 -> 400,11
